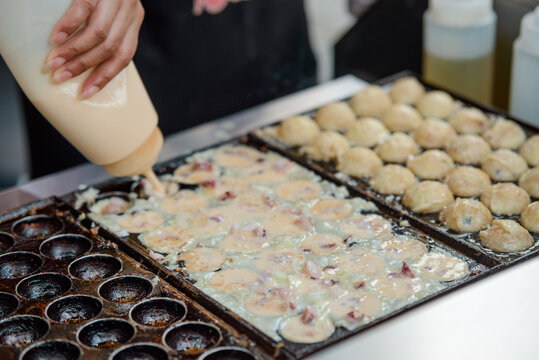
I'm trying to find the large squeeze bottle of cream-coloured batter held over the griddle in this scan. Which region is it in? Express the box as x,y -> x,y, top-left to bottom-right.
0,0 -> 163,190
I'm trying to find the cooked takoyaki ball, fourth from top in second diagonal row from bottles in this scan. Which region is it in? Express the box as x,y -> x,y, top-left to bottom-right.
445,134 -> 491,165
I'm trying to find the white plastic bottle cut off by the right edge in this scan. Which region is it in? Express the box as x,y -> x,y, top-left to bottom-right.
509,5 -> 539,127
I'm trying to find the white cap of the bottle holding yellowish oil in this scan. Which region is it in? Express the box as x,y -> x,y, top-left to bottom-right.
428,0 -> 493,26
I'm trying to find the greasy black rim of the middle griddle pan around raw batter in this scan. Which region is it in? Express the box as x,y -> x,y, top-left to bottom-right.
66,136 -> 490,359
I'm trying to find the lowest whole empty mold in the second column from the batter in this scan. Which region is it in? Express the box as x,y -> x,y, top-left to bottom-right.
77,318 -> 135,348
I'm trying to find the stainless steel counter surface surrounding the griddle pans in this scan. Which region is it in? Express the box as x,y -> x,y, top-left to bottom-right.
0,76 -> 539,360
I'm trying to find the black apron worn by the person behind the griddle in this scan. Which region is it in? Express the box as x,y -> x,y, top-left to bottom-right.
24,0 -> 316,177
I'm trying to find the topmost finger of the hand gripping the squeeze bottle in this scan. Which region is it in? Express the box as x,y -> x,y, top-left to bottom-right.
51,0 -> 96,44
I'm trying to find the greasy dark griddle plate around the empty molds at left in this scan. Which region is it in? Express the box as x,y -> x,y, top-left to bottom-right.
0,199 -> 269,359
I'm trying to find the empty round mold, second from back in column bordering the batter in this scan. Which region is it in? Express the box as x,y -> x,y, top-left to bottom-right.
39,234 -> 92,260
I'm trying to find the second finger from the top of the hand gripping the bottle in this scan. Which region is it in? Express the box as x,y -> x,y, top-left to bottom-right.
47,0 -> 120,71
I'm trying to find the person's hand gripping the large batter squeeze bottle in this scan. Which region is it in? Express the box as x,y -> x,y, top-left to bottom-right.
47,0 -> 144,99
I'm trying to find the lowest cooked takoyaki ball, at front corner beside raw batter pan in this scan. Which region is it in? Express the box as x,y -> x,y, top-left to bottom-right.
479,220 -> 534,252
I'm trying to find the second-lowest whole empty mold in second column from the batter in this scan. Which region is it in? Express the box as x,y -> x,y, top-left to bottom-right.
45,295 -> 103,324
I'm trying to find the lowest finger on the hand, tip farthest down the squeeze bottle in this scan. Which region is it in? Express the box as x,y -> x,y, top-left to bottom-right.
81,17 -> 142,99
